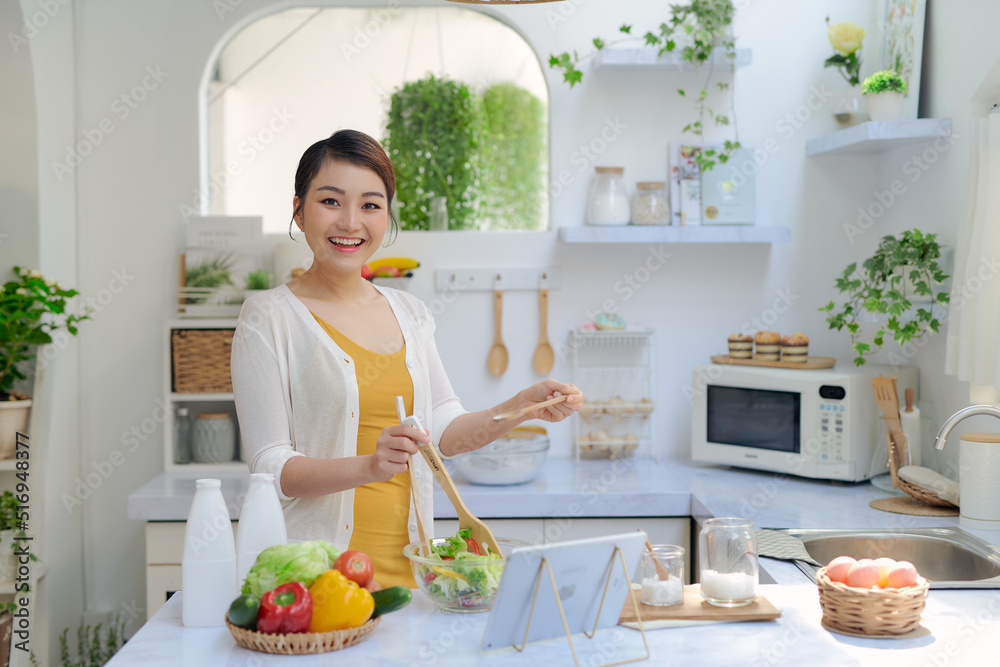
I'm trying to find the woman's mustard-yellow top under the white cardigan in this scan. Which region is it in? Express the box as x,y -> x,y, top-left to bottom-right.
313,313 -> 417,588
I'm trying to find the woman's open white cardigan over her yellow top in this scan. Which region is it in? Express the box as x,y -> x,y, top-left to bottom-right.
232,285 -> 465,550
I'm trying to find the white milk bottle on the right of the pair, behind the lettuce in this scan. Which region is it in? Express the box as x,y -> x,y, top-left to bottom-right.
236,472 -> 288,582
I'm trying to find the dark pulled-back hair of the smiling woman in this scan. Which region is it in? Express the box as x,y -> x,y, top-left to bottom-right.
288,130 -> 399,243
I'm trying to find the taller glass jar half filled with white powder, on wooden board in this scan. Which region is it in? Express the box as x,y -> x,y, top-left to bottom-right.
698,517 -> 759,607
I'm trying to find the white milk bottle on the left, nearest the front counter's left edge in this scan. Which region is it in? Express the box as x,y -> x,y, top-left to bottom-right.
181,479 -> 239,628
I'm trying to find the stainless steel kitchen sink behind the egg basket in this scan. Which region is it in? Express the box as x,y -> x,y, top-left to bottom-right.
775,527 -> 1000,588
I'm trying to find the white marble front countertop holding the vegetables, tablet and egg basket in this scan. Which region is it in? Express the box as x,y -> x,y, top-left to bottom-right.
108,584 -> 1000,667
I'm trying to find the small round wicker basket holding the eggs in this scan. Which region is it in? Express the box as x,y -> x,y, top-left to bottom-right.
816,567 -> 930,636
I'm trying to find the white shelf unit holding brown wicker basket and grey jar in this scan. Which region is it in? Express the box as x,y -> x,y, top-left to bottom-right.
163,319 -> 247,473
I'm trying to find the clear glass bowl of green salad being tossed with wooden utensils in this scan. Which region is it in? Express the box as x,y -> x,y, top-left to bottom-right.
403,537 -> 528,612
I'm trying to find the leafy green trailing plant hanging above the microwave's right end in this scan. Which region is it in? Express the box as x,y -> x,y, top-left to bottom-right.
820,229 -> 949,366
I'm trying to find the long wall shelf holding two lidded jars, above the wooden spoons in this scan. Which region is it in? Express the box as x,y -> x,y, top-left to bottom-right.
559,225 -> 792,243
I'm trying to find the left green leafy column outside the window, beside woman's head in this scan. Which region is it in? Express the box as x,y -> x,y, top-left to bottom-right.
383,74 -> 484,230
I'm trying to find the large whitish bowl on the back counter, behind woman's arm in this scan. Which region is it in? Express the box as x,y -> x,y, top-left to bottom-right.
450,429 -> 549,486
